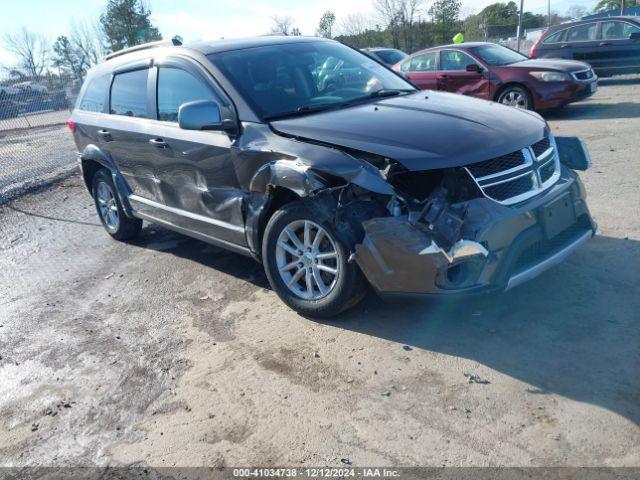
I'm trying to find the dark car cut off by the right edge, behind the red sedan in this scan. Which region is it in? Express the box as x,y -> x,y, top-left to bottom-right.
531,17 -> 640,77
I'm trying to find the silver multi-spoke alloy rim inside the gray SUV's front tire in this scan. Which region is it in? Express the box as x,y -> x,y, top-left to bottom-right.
276,220 -> 341,300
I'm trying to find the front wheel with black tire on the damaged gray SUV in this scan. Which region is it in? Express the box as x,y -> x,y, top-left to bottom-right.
262,202 -> 366,317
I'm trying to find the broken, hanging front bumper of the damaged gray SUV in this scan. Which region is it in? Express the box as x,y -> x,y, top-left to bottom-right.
355,168 -> 596,296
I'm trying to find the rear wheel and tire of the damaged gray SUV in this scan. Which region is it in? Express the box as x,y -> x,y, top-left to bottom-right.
91,168 -> 142,241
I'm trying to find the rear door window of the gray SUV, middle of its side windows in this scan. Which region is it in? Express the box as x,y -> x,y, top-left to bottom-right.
109,70 -> 149,118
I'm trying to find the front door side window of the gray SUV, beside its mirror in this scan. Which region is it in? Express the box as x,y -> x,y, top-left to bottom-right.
158,68 -> 218,122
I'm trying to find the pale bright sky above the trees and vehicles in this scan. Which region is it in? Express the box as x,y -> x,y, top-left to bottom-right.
0,0 -> 596,65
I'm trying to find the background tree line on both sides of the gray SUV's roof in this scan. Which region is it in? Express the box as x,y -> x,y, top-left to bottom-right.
0,0 -> 640,80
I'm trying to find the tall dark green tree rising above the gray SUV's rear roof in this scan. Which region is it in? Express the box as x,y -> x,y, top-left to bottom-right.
100,0 -> 162,52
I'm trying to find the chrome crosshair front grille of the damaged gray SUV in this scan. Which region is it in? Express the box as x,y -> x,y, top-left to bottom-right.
465,134 -> 560,205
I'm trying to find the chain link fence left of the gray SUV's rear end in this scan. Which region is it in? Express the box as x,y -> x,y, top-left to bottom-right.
0,76 -> 80,204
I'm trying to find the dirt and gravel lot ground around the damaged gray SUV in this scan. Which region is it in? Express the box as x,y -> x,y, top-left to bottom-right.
0,77 -> 640,466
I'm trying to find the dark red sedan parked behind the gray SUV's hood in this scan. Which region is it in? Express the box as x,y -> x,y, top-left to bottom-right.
393,43 -> 598,110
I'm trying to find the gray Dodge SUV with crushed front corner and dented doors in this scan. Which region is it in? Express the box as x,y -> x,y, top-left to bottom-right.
69,37 -> 595,317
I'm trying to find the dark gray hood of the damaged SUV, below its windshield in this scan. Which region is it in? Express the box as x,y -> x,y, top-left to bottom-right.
271,91 -> 546,170
